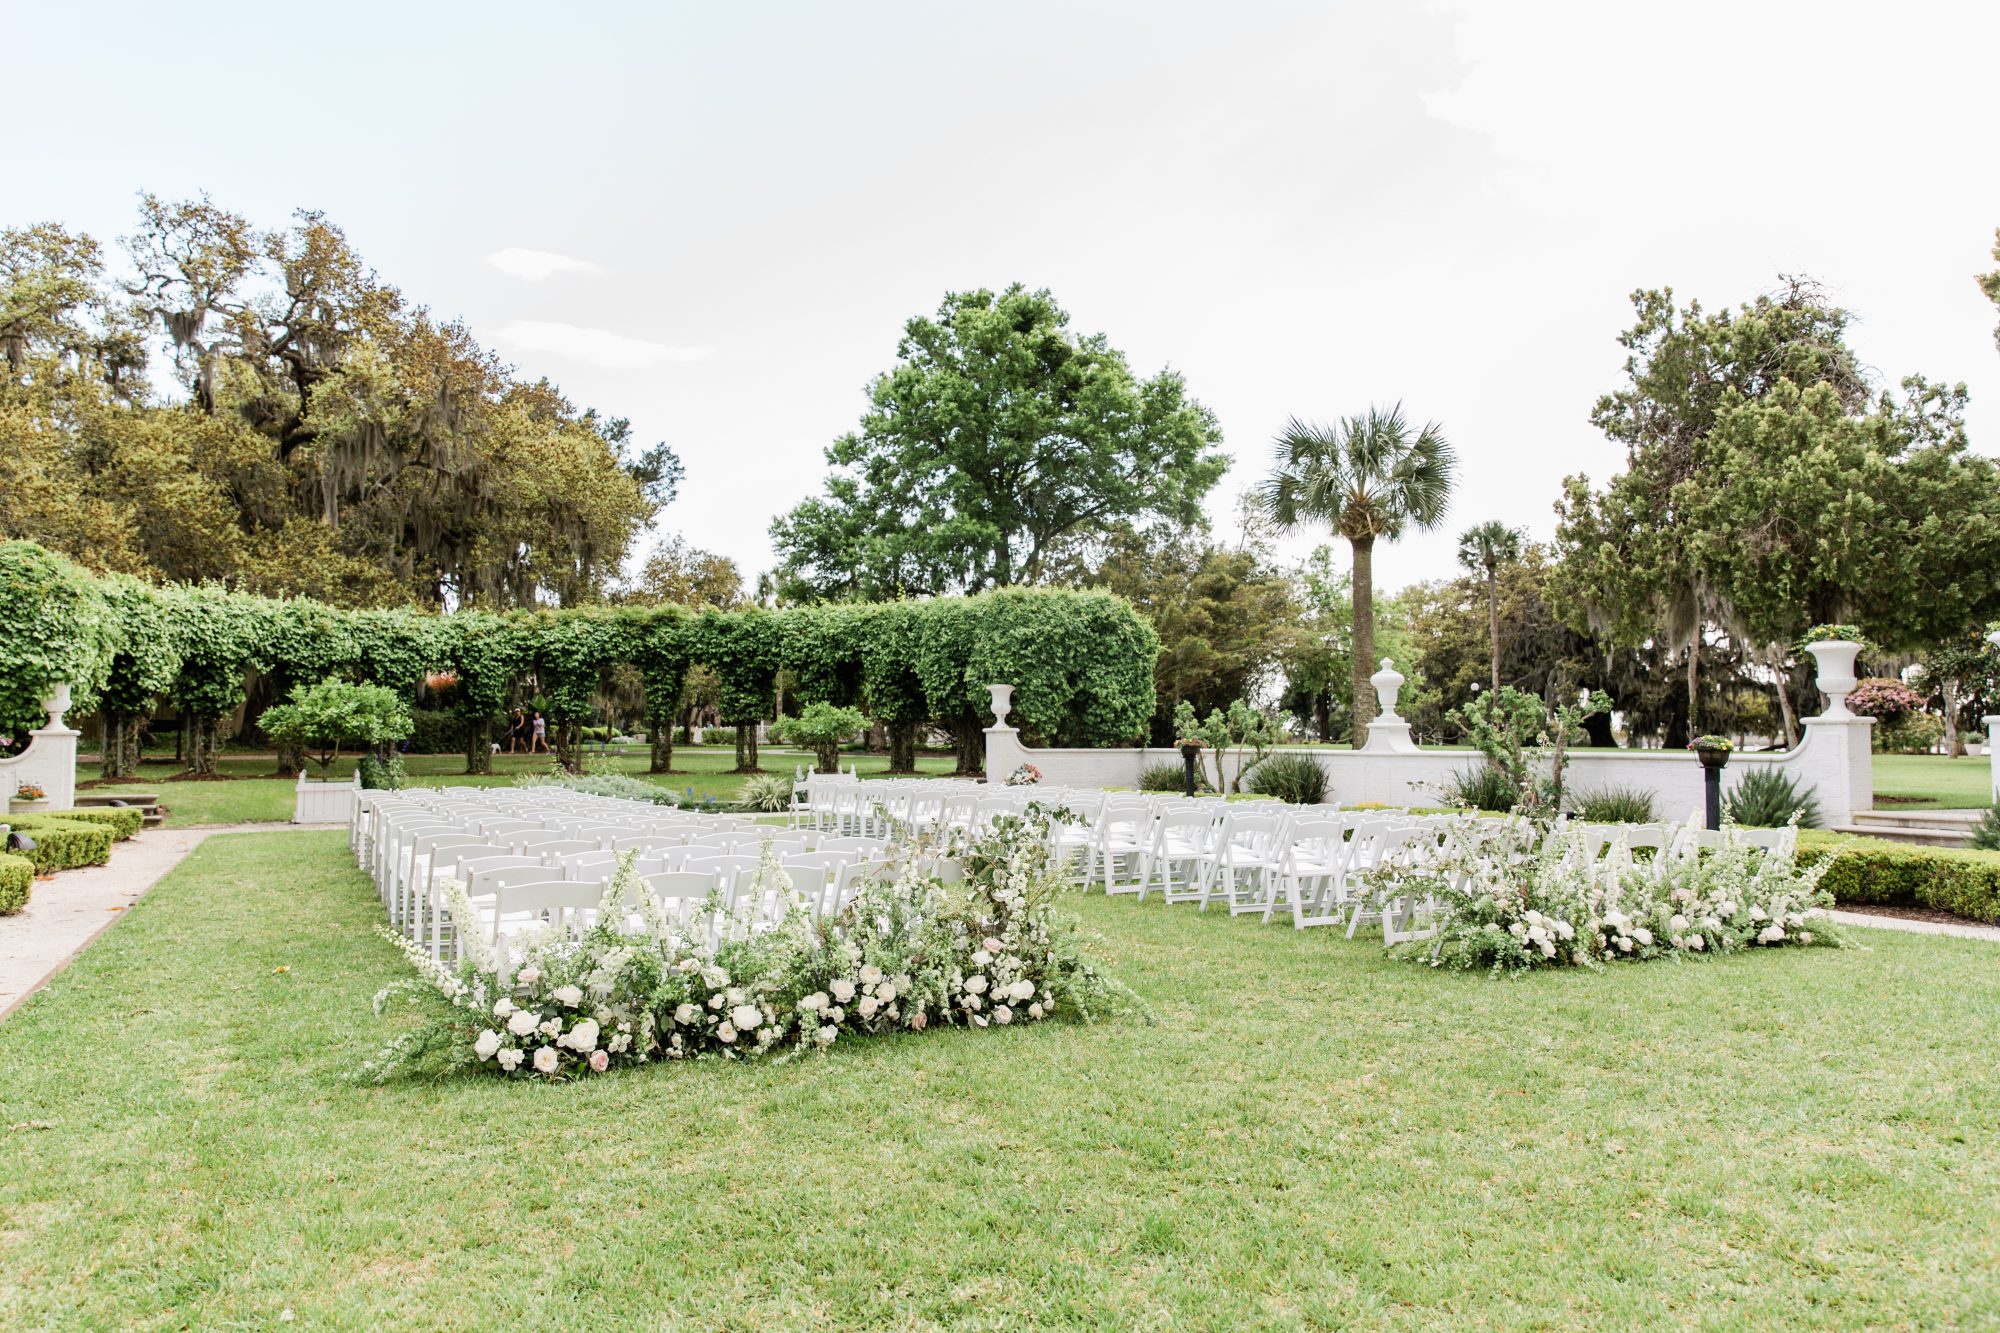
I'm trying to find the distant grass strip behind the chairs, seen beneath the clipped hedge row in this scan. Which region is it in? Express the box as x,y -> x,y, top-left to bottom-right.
76,747 -> 952,827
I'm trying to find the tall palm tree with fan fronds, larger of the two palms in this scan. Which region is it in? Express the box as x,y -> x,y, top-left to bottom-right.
1260,402 -> 1458,749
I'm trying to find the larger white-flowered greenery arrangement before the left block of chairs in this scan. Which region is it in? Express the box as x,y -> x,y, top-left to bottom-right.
364,807 -> 1138,1081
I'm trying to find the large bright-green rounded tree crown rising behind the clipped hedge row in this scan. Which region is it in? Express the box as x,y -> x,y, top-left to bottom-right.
772,284 -> 1228,600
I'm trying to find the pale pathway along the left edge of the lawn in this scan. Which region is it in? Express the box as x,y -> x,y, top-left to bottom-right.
0,825 -> 342,1023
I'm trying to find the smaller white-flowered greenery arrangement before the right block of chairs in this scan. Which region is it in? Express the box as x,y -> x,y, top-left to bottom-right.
1372,821 -> 1842,973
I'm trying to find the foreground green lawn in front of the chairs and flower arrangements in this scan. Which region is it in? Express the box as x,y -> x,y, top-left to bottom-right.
0,833 -> 2000,1329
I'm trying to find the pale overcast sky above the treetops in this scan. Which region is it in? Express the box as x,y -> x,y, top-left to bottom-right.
15,0 -> 2000,586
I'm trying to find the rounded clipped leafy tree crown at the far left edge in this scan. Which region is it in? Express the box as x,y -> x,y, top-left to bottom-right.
0,542 -> 118,741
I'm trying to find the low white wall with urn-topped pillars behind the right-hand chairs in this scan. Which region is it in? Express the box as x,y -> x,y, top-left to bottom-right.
986,644 -> 1874,825
